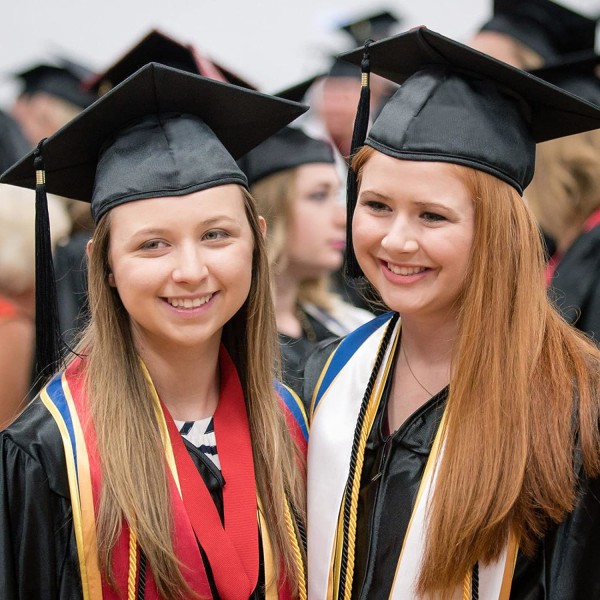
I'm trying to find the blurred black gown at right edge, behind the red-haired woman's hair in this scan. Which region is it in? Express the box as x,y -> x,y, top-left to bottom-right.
549,226 -> 600,344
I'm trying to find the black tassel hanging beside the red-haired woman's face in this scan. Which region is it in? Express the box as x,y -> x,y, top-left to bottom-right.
345,40 -> 372,278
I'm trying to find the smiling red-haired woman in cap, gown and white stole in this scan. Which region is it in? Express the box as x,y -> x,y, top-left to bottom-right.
307,27 -> 600,600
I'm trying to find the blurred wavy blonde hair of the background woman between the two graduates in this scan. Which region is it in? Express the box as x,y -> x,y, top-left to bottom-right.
251,169 -> 335,310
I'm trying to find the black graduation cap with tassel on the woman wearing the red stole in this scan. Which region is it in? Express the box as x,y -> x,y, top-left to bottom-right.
0,63 -> 306,374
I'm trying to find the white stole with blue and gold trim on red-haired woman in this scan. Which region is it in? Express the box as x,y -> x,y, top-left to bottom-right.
308,314 -> 517,600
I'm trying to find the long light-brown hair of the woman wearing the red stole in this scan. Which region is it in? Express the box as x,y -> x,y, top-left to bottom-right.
78,188 -> 305,598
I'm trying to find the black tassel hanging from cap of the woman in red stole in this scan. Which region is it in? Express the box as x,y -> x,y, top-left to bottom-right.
33,139 -> 61,385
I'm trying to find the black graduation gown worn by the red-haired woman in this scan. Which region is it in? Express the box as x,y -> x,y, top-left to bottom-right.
305,344 -> 600,600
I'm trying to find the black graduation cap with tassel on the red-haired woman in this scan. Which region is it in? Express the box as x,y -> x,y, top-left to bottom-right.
342,27 -> 600,276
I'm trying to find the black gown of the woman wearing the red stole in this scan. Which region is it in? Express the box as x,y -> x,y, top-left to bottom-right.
0,399 -> 264,600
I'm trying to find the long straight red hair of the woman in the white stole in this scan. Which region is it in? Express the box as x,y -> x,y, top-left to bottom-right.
353,148 -> 600,596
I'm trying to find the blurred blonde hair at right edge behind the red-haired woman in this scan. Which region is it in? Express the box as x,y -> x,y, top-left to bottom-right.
525,131 -> 600,242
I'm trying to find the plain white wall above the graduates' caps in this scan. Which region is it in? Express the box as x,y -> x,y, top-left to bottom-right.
0,0 -> 492,106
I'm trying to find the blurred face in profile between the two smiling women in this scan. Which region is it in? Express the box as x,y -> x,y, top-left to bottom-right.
287,163 -> 346,281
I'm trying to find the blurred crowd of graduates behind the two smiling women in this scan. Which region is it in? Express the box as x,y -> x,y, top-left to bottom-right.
0,0 -> 600,429
